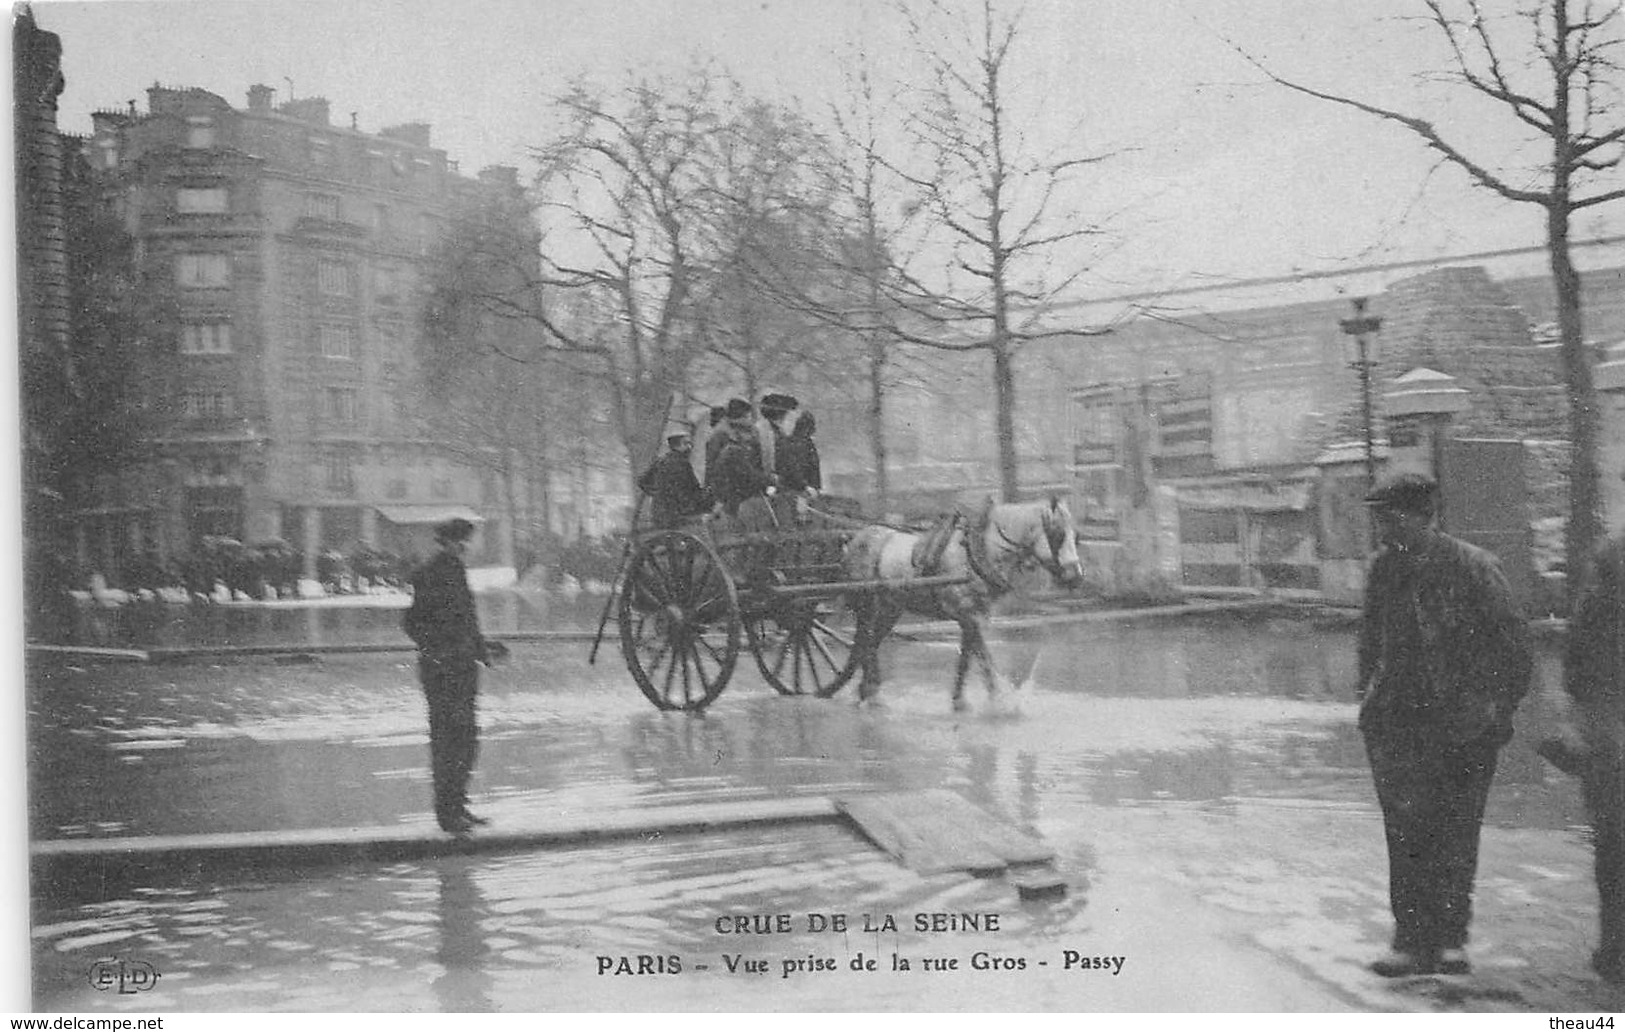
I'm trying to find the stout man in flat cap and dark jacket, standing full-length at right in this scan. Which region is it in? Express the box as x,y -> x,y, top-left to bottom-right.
1355,473 -> 1532,978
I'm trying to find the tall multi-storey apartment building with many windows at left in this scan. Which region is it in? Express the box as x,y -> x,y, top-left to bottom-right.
80,85 -> 517,574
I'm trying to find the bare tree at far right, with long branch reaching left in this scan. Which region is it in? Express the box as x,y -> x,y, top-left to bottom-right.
1243,0 -> 1625,596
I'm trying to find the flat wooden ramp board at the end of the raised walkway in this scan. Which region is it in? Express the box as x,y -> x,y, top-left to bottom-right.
835,788 -> 1055,874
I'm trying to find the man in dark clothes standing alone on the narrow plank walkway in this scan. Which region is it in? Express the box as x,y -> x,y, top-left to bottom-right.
405,518 -> 507,835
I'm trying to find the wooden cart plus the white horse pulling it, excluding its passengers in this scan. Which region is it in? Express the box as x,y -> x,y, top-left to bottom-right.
593,499 -> 1081,712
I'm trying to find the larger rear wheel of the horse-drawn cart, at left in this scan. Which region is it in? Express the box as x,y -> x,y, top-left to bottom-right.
619,530 -> 739,713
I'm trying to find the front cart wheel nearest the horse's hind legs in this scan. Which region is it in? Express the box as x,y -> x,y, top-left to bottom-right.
748,600 -> 858,699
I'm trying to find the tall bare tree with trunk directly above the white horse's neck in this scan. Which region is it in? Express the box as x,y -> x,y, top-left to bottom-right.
897,0 -> 1110,501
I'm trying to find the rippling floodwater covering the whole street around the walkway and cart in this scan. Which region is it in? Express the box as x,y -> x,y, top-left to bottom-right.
29,596 -> 1610,1011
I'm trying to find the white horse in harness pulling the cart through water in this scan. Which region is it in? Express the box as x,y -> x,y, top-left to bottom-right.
843,497 -> 1084,710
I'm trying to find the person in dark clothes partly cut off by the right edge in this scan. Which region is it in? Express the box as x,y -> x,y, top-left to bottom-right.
1541,535 -> 1625,982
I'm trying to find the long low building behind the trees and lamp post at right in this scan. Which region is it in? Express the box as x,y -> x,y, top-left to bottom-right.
827,250 -> 1625,596
